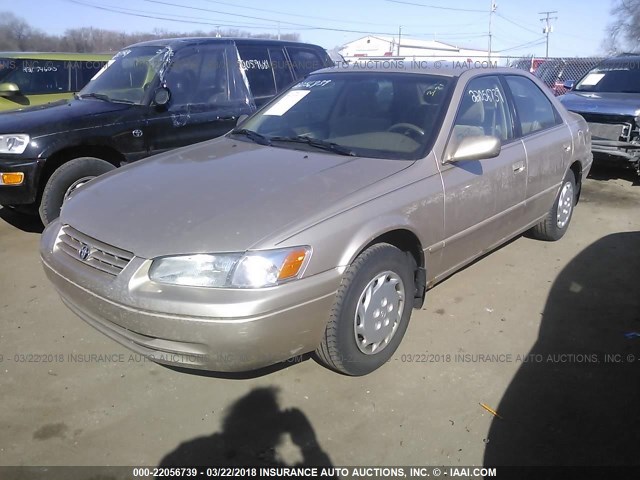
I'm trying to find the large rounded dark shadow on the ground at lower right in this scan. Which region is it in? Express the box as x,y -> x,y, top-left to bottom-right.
484,232 -> 640,466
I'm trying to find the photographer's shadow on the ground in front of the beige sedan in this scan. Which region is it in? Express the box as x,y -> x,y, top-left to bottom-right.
160,388 -> 332,467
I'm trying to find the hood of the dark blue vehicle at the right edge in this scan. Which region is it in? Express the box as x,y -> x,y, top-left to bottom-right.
558,92 -> 640,117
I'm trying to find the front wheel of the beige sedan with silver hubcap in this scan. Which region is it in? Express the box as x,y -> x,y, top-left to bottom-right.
316,243 -> 415,376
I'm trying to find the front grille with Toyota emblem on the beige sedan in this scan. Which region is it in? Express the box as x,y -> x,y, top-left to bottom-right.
58,225 -> 133,276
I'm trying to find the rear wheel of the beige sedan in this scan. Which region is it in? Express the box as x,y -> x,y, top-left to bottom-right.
531,170 -> 578,241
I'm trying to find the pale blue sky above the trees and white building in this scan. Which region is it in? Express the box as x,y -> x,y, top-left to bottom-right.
0,0 -> 612,56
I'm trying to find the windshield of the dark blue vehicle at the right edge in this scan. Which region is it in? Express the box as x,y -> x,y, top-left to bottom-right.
574,62 -> 640,93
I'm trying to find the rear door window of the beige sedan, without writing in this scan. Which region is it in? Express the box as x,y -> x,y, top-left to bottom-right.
506,75 -> 561,136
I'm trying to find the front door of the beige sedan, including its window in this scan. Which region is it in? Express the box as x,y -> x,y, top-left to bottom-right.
440,75 -> 527,275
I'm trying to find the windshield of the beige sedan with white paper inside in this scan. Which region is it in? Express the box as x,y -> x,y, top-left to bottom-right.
231,72 -> 451,159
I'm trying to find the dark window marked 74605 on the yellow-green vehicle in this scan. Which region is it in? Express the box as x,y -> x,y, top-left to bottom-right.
3,60 -> 71,95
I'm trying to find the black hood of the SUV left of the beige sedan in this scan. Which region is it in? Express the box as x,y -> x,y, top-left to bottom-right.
0,99 -> 135,135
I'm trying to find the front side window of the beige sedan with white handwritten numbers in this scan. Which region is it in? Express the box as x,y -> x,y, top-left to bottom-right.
449,76 -> 514,153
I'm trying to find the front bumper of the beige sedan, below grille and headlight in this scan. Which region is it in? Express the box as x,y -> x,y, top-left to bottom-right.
41,222 -> 341,372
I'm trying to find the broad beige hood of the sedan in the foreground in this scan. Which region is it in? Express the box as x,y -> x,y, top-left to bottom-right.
60,137 -> 413,258
